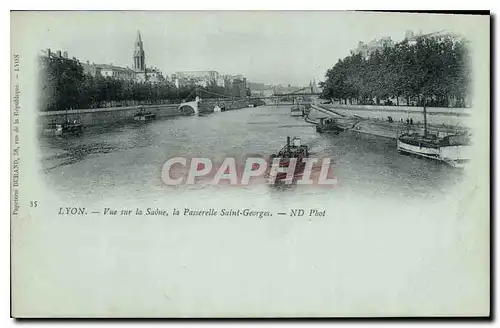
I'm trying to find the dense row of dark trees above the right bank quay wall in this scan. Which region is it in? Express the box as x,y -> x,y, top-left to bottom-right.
320,37 -> 471,107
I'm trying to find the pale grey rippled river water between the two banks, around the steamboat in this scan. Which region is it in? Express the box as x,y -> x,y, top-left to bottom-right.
40,106 -> 463,205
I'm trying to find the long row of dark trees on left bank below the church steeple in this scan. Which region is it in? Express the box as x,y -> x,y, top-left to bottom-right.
39,57 -> 250,111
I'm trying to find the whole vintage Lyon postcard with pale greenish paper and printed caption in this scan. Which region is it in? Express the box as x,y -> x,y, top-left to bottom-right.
10,11 -> 491,318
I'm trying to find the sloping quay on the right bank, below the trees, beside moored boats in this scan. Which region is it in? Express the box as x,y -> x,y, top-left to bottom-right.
307,105 -> 467,139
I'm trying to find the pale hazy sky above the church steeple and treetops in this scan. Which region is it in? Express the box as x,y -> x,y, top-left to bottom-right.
15,11 -> 484,85
